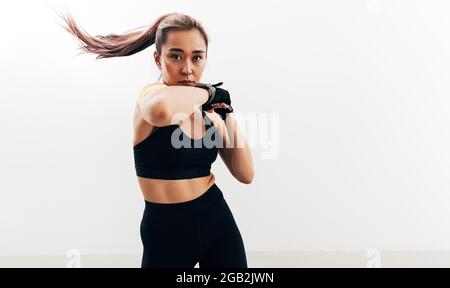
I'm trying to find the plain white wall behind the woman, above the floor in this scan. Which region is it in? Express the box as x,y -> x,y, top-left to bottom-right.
0,0 -> 450,255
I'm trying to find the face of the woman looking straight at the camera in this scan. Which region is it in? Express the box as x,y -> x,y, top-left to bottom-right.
154,29 -> 207,86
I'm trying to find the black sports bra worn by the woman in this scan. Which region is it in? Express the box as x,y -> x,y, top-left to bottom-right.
133,111 -> 219,179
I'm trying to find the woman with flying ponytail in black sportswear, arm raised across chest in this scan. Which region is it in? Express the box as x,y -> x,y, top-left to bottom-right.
63,13 -> 254,268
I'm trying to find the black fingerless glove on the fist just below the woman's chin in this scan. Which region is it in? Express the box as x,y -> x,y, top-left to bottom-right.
194,82 -> 233,120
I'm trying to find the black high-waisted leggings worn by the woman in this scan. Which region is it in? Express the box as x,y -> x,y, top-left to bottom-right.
140,184 -> 247,268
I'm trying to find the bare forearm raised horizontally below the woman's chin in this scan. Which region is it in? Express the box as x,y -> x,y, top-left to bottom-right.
159,86 -> 208,125
